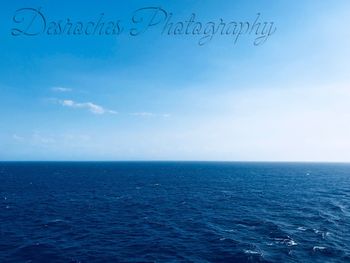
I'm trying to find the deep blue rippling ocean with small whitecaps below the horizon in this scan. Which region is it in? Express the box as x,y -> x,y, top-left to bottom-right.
0,162 -> 350,263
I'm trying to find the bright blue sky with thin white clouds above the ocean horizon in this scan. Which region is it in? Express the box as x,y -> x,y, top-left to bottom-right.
0,0 -> 350,162
